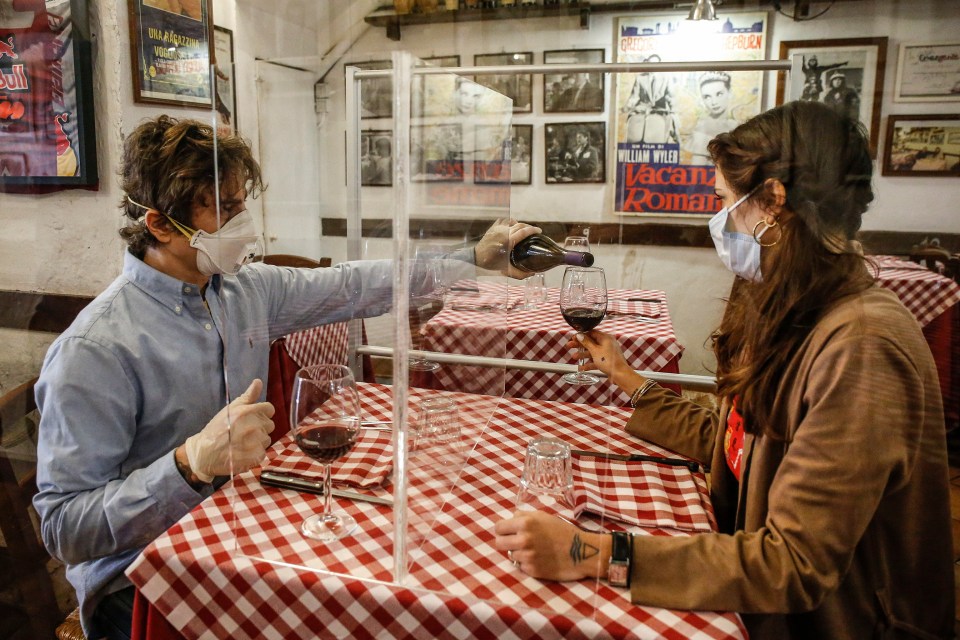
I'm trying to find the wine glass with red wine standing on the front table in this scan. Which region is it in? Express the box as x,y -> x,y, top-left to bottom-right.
290,364 -> 360,542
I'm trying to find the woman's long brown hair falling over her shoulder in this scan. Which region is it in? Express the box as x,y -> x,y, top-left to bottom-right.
708,102 -> 873,440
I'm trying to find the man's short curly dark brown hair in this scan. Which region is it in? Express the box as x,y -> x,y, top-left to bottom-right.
119,115 -> 265,258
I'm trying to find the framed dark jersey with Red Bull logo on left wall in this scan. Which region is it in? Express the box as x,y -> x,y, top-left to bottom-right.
0,0 -> 99,193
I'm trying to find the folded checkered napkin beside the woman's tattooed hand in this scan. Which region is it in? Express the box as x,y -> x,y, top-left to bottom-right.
573,455 -> 714,531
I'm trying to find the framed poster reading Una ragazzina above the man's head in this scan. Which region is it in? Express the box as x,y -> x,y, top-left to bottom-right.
127,0 -> 213,107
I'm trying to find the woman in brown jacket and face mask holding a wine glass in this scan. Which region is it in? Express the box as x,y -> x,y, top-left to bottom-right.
496,102 -> 954,639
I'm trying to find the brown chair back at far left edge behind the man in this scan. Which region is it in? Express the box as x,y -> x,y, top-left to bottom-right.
0,378 -> 63,638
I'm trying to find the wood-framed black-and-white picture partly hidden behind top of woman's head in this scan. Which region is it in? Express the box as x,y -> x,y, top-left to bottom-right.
777,38 -> 887,158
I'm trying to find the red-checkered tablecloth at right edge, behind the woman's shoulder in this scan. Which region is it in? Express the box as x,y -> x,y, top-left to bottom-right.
870,256 -> 960,327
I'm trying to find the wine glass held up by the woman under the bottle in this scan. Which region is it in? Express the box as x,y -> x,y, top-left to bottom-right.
560,267 -> 607,385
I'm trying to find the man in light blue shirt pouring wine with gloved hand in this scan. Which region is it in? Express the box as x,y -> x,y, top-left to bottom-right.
34,116 -> 536,638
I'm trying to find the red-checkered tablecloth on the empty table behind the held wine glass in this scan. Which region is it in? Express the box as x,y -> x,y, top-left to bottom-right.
421,283 -> 683,406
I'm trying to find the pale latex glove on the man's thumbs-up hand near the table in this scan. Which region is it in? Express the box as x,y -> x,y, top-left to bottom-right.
184,378 -> 274,482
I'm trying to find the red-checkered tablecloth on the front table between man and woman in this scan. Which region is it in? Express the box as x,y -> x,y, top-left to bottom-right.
127,385 -> 746,640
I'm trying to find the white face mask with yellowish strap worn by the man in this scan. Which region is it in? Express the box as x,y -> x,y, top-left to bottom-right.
127,197 -> 260,276
